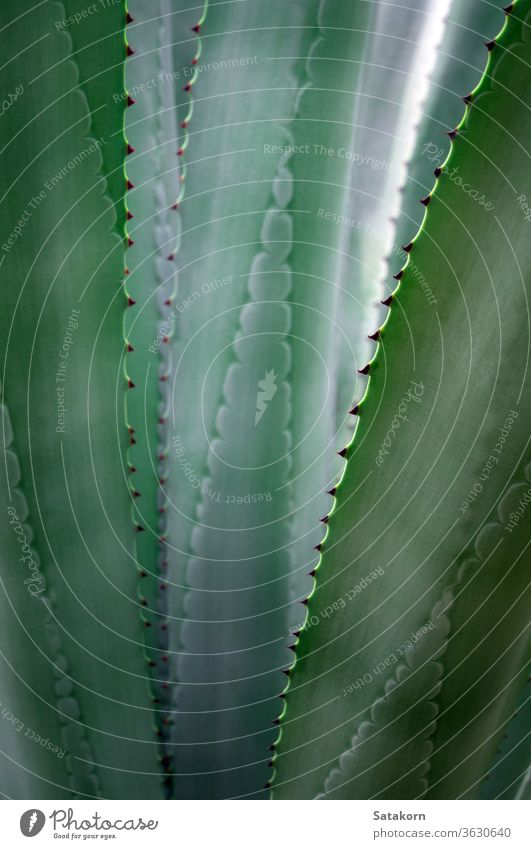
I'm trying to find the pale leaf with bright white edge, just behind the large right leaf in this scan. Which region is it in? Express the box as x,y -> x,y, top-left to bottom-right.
290,0 -> 445,608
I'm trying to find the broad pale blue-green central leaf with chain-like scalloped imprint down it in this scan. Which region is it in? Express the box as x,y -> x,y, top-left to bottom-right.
168,2 -> 316,798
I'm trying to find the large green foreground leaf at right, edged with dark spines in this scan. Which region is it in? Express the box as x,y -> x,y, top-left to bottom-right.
274,0 -> 531,798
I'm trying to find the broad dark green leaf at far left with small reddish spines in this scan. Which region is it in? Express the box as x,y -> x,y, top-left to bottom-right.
0,0 -> 161,798
